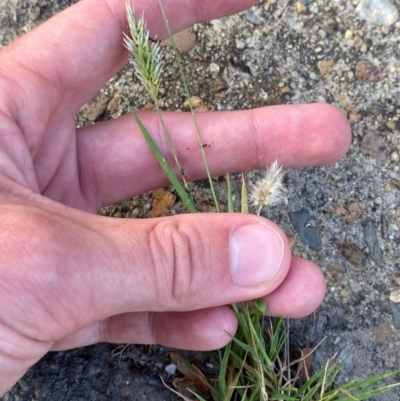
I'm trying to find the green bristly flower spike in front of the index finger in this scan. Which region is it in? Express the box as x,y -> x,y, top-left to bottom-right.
124,1 -> 163,102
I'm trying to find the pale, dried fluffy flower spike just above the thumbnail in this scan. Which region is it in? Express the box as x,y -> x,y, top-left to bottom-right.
250,161 -> 287,215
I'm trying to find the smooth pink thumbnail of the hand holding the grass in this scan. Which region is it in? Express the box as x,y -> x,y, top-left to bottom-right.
230,224 -> 283,287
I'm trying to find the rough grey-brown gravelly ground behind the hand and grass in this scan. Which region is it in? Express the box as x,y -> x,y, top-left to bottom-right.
0,0 -> 400,401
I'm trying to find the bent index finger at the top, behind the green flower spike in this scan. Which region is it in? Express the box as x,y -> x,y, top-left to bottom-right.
3,0 -> 256,109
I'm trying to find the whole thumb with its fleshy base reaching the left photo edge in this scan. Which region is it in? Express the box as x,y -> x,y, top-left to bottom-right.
0,206 -> 291,341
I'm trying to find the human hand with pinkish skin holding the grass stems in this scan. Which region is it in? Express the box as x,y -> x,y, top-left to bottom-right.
0,0 -> 350,394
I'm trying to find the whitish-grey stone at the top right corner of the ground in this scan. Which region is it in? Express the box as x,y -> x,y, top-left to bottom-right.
356,0 -> 399,26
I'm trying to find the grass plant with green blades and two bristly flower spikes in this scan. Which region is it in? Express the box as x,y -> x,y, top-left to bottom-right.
124,0 -> 400,401
